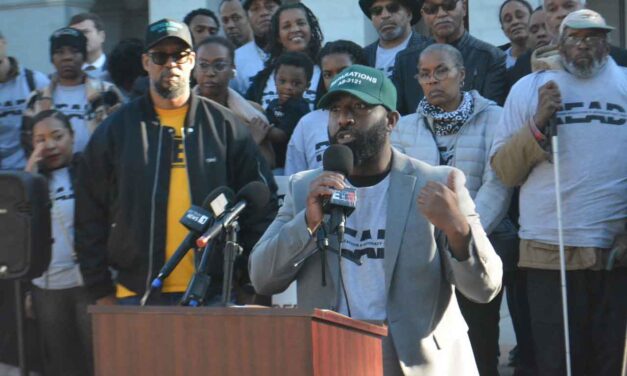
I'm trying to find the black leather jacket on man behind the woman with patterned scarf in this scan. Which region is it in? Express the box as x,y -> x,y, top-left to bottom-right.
392,32 -> 505,115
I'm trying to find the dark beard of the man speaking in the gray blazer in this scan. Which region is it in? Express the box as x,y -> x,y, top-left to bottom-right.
329,118 -> 387,167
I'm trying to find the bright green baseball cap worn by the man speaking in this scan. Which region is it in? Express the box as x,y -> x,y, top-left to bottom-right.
318,64 -> 396,111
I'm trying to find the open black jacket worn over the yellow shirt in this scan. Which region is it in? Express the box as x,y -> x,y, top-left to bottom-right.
75,93 -> 277,299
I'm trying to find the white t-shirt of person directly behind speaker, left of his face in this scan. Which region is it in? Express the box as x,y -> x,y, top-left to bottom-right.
285,109 -> 329,176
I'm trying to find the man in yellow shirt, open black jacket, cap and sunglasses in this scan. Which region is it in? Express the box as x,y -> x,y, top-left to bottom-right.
75,19 -> 276,304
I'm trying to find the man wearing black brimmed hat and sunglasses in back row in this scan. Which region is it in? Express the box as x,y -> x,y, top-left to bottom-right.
359,0 -> 427,78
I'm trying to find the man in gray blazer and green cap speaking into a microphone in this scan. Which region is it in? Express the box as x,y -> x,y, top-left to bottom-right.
249,65 -> 502,375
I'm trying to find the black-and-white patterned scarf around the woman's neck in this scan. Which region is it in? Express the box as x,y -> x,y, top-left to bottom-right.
416,91 -> 475,136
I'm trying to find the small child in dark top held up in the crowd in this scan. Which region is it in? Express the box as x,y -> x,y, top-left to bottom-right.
266,52 -> 313,175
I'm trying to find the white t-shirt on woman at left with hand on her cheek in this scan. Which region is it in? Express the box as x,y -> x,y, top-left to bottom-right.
33,168 -> 83,289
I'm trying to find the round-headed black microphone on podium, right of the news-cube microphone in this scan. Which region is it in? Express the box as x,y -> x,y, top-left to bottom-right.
196,181 -> 270,248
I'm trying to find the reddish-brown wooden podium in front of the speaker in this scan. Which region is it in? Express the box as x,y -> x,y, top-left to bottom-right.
89,306 -> 387,376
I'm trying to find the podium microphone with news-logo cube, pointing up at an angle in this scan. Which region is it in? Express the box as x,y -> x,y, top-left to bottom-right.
151,187 -> 235,289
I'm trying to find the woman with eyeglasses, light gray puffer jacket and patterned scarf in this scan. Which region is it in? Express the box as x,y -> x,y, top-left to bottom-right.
391,44 -> 516,376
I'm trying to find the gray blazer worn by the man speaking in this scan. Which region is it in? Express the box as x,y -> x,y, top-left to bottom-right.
249,150 -> 502,375
